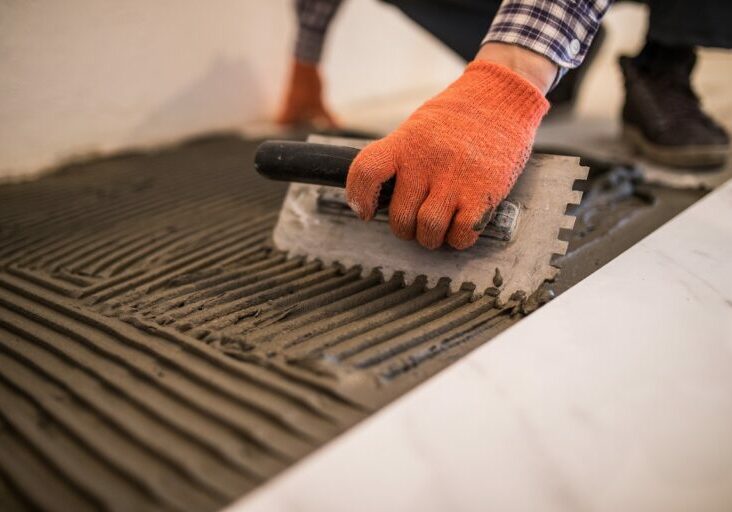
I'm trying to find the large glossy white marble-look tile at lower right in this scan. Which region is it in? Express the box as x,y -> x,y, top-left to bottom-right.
231,182 -> 732,512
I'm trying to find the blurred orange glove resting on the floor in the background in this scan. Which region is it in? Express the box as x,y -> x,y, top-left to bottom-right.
277,60 -> 338,129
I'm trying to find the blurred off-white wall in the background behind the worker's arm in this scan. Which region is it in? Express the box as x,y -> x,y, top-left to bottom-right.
0,0 -> 460,178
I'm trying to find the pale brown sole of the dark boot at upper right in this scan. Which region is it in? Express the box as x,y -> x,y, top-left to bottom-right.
622,124 -> 729,167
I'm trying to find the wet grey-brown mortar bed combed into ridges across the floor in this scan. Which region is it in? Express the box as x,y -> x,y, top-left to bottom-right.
0,136 -> 703,511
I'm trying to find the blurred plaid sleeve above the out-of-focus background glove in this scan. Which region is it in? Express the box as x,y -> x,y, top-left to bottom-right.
295,0 -> 341,63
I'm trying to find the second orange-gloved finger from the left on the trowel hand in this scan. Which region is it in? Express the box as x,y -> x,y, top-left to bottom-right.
389,169 -> 429,240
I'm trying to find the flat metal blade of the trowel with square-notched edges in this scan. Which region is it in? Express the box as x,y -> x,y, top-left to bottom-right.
272,137 -> 589,302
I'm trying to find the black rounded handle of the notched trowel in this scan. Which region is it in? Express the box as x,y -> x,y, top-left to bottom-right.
254,140 -> 394,208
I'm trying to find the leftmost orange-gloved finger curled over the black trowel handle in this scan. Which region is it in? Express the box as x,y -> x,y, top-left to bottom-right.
346,139 -> 396,220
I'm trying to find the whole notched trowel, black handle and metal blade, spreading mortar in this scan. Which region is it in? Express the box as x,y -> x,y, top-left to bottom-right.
255,136 -> 588,300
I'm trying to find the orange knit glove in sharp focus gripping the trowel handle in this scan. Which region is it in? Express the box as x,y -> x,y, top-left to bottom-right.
346,61 -> 549,249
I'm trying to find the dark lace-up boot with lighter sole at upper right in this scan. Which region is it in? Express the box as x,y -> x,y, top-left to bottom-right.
620,43 -> 729,167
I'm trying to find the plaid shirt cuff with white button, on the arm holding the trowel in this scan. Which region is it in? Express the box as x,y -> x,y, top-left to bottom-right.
483,0 -> 613,79
